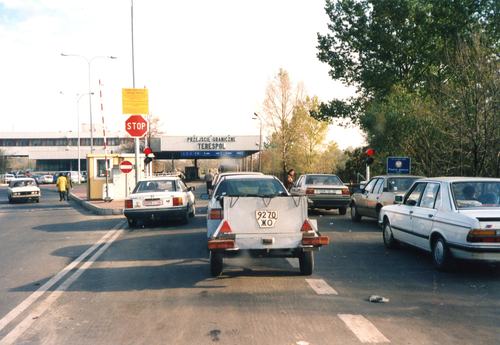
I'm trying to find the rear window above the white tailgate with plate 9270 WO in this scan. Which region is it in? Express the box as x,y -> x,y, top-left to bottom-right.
215,179 -> 288,197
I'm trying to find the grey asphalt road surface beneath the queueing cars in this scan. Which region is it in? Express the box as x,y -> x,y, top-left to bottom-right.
0,188 -> 500,345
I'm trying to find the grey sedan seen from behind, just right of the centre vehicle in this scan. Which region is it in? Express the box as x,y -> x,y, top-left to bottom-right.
290,174 -> 351,215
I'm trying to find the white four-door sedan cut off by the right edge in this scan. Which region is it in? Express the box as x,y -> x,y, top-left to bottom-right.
379,177 -> 500,269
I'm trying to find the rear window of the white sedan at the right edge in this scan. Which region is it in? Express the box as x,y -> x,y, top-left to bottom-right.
451,181 -> 500,209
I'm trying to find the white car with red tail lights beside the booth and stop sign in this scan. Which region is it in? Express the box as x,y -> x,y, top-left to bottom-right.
123,176 -> 196,227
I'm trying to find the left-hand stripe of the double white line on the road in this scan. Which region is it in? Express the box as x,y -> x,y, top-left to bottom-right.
0,222 -> 124,331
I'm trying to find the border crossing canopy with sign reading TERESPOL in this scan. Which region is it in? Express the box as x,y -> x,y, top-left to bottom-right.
151,135 -> 260,180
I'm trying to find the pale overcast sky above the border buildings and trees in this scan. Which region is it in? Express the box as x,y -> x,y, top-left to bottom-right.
0,0 -> 363,148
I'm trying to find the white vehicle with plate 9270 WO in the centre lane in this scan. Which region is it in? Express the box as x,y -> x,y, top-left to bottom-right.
203,174 -> 329,276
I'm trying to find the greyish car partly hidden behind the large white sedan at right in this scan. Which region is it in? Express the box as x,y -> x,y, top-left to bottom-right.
350,175 -> 422,222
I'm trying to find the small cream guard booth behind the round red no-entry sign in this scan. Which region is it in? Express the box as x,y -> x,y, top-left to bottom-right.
87,153 -> 144,200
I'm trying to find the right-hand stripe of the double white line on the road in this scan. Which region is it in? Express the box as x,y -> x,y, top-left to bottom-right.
0,230 -> 124,345
